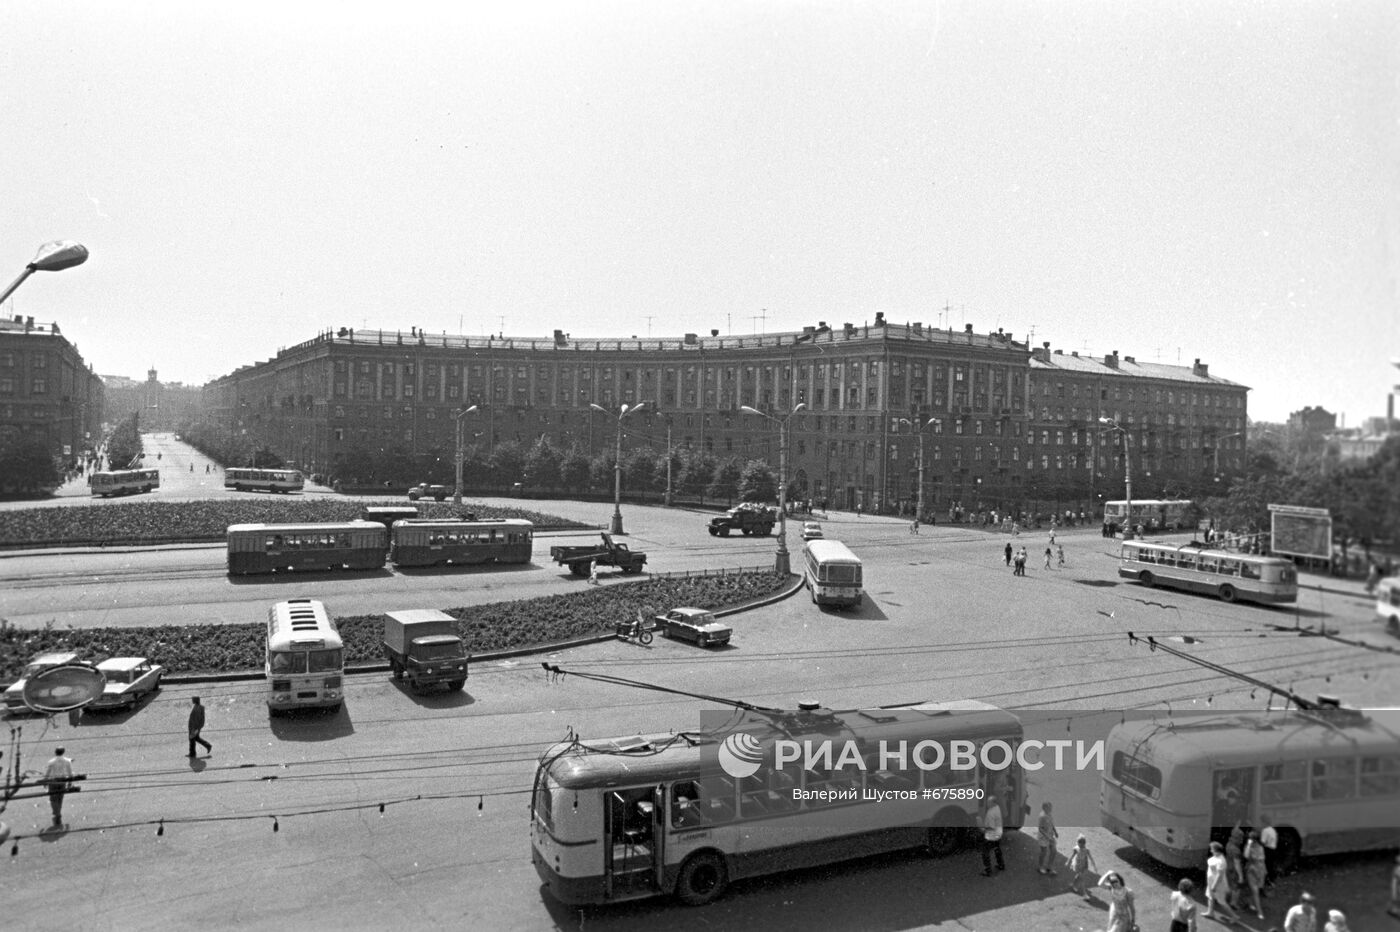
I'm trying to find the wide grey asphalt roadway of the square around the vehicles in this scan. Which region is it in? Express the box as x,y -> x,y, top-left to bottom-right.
0,459 -> 1400,931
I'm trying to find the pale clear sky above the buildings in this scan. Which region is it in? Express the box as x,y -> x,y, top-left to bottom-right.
0,0 -> 1400,425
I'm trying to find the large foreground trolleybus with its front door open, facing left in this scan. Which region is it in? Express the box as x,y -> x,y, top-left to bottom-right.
531,702 -> 1026,905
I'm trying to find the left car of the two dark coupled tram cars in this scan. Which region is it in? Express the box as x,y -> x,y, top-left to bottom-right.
228,521 -> 389,575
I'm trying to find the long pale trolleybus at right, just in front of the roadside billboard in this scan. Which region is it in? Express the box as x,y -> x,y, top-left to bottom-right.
1119,540 -> 1298,603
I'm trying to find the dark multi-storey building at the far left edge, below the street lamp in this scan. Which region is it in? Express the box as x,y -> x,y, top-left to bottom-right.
0,318 -> 104,463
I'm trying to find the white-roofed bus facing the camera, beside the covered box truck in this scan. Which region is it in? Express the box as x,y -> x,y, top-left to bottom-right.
263,599 -> 346,715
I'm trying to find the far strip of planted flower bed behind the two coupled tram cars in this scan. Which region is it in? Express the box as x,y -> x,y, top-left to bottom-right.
0,497 -> 580,547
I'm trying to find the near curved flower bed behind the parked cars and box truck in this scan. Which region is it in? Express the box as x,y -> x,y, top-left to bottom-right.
0,572 -> 788,674
